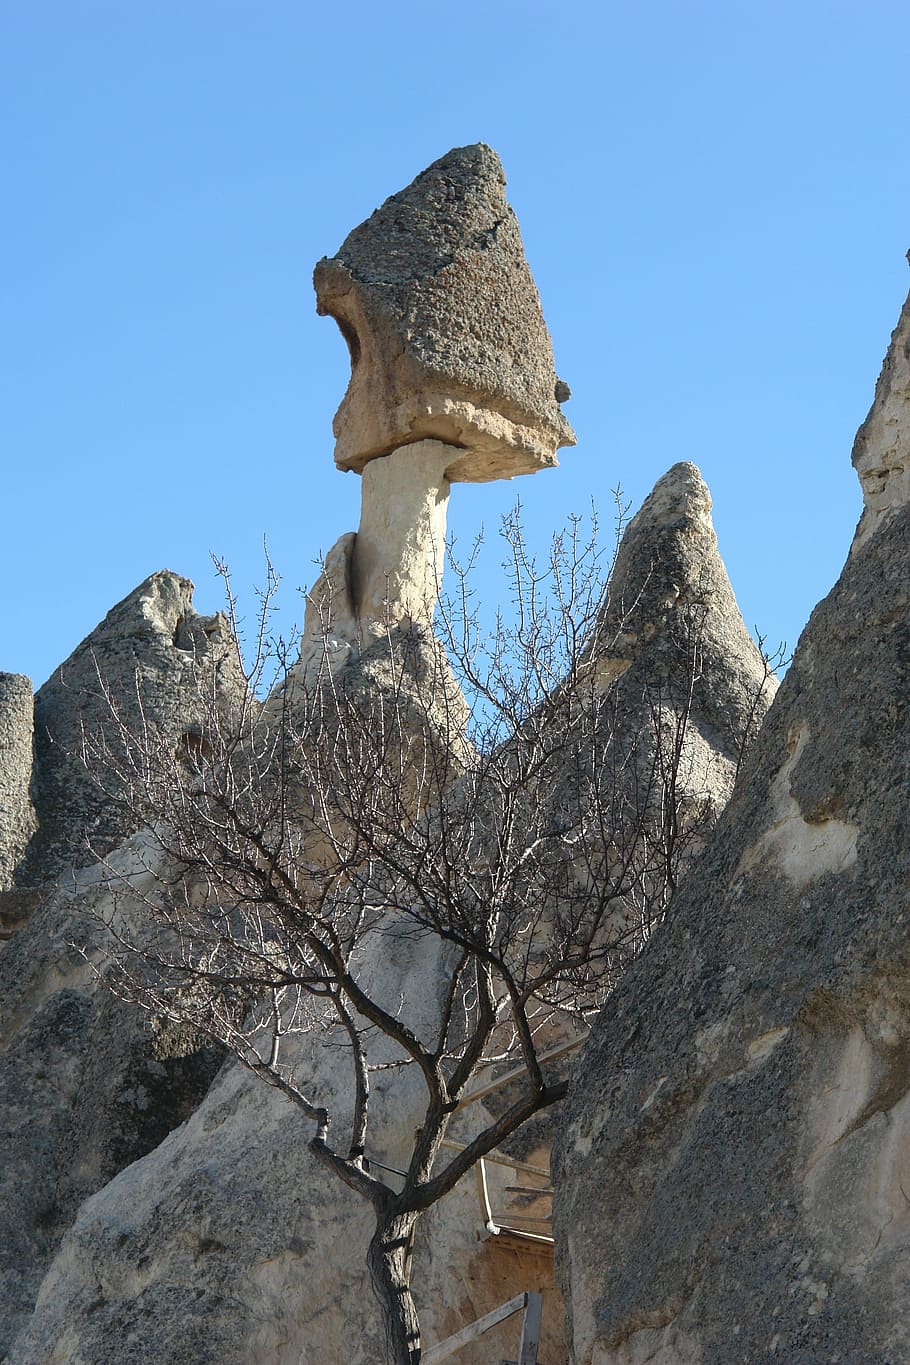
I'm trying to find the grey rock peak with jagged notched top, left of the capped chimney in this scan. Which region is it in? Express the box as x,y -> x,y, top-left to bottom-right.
23,569 -> 241,885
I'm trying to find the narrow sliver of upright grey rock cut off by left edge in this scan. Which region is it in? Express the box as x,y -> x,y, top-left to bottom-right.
0,673 -> 37,889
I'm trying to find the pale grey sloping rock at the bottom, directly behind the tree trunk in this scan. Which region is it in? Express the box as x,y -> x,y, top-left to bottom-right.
7,906 -> 562,1365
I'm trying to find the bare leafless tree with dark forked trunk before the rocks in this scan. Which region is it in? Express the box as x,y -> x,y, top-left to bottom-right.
85,516 -> 774,1365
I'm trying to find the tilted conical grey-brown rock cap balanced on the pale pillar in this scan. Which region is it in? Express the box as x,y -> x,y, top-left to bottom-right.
314,143 -> 574,482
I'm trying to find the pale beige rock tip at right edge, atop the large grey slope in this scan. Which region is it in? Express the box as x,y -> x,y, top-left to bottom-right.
853,277 -> 910,545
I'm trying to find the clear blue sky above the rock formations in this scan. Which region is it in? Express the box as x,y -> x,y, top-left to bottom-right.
0,0 -> 910,684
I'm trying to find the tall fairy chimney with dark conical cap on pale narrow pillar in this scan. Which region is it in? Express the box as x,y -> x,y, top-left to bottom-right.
302,143 -> 574,655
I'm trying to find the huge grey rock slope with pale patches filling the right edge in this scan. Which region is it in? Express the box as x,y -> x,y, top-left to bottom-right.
554,282 -> 910,1365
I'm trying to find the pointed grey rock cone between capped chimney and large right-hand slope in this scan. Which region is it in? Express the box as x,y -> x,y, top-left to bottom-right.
488,463 -> 778,1159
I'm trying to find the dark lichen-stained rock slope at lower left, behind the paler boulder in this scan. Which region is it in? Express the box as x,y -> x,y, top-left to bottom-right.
0,854 -> 220,1360
